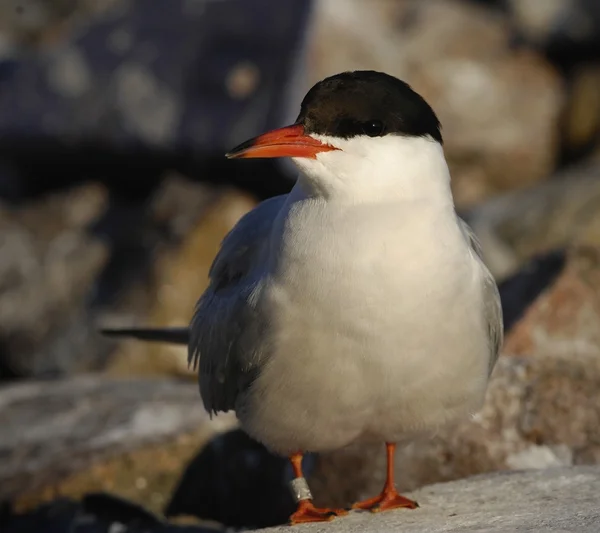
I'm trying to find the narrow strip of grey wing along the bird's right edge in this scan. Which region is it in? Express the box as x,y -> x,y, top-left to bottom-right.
457,217 -> 504,374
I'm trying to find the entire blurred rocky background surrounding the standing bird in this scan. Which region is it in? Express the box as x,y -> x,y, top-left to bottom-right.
0,0 -> 600,533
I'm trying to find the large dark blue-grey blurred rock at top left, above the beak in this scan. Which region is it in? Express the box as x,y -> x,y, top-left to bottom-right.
0,0 -> 311,153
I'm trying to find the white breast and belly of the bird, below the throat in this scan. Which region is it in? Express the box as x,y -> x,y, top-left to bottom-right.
241,194 -> 489,454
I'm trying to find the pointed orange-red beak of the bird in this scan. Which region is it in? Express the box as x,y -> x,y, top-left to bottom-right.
225,124 -> 337,159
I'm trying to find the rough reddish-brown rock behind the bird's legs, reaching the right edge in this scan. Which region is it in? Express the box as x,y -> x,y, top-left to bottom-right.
309,248 -> 600,505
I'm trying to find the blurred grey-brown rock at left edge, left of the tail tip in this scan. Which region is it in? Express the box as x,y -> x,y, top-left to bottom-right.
0,185 -> 108,378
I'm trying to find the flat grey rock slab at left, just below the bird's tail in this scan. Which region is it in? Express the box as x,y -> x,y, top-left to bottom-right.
0,376 -> 208,500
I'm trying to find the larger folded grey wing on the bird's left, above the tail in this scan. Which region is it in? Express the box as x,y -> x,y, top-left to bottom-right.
188,196 -> 285,413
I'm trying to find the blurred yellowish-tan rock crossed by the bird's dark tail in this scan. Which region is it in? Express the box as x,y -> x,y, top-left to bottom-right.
101,187 -> 256,380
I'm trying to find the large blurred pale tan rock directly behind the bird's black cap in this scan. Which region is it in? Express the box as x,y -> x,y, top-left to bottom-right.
307,0 -> 563,207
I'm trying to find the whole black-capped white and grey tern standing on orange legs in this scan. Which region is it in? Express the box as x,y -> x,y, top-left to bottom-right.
105,70 -> 504,524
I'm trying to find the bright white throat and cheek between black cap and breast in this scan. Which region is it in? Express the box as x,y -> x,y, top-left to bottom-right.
293,135 -> 453,206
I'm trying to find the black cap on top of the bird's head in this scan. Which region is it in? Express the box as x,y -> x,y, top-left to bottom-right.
296,70 -> 442,144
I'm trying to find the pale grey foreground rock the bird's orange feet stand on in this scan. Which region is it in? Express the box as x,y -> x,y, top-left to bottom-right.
262,467 -> 600,533
